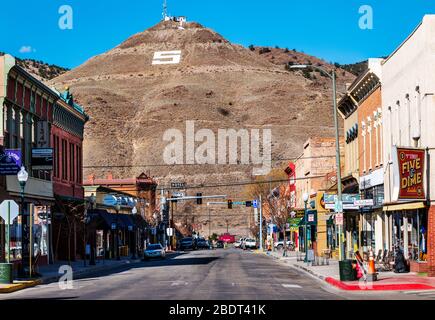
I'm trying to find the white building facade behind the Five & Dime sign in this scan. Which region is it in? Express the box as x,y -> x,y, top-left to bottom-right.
382,15 -> 435,276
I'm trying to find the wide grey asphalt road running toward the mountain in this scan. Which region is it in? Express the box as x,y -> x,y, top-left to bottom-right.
0,249 -> 435,300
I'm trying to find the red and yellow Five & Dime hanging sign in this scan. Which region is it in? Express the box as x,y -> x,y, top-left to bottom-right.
392,147 -> 426,200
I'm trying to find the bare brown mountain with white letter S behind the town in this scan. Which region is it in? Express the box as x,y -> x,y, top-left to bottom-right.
50,21 -> 355,235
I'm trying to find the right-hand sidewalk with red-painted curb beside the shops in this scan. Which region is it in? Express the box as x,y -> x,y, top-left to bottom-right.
265,252 -> 435,291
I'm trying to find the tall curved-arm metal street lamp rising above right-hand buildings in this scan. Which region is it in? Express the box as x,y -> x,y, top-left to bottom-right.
290,64 -> 344,261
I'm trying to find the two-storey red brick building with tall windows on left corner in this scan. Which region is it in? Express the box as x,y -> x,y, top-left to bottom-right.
0,54 -> 87,268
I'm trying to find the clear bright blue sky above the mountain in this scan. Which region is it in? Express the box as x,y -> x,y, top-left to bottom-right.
0,0 -> 435,68
